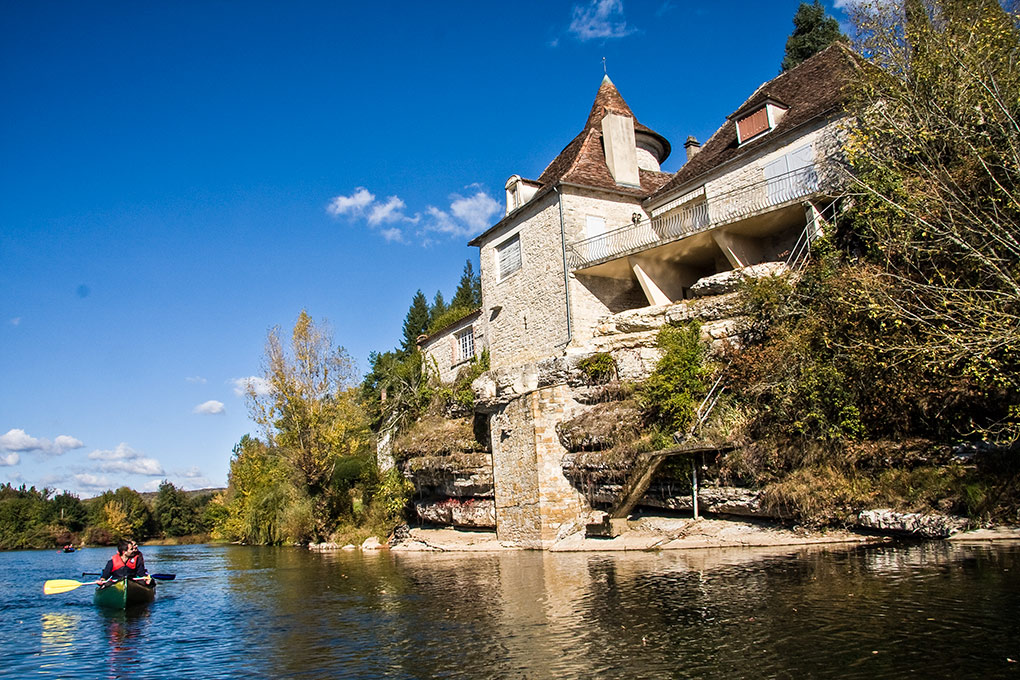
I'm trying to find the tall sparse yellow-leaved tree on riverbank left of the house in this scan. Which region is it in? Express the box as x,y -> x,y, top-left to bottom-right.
248,311 -> 373,536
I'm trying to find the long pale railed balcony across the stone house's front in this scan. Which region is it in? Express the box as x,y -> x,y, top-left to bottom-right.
567,165 -> 818,270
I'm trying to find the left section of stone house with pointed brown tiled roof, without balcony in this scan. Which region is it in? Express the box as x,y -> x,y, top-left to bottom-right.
470,75 -> 671,369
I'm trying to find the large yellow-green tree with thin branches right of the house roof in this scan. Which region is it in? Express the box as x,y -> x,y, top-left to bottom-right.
843,0 -> 1020,436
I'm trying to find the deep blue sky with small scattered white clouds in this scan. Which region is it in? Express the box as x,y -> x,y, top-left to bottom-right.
0,0 -> 848,498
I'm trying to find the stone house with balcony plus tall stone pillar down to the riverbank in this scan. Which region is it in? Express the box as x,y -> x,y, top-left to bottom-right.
397,45 -> 857,547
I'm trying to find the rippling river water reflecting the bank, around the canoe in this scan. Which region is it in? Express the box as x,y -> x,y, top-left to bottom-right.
0,542 -> 1020,680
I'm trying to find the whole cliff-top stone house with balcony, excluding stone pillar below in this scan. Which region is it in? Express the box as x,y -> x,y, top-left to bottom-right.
471,46 -> 855,369
